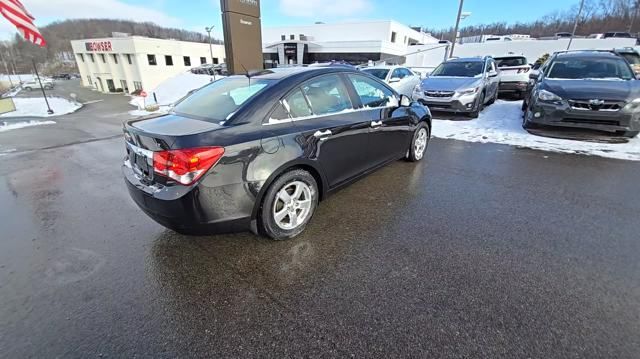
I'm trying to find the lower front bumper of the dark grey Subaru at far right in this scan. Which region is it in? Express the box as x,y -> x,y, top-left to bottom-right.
526,102 -> 640,132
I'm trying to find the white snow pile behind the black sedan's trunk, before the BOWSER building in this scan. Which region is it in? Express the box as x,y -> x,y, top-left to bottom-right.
129,72 -> 222,109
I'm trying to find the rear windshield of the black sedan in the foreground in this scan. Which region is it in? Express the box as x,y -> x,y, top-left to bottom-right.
173,76 -> 273,122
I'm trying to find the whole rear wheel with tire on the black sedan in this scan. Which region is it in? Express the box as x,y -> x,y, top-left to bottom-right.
260,169 -> 319,240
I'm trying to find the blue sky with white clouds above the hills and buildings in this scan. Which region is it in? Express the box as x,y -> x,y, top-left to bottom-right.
0,0 -> 579,39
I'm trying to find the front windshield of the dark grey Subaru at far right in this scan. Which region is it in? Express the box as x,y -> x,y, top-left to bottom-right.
547,58 -> 634,80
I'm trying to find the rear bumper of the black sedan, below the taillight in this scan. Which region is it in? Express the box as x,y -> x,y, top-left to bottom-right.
122,165 -> 252,234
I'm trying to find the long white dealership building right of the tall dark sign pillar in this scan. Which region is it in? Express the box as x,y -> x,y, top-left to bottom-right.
262,20 -> 438,67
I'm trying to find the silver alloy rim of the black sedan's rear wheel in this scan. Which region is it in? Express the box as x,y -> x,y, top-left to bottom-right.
272,181 -> 313,231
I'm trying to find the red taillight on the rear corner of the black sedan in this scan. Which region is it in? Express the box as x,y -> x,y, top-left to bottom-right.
153,147 -> 224,186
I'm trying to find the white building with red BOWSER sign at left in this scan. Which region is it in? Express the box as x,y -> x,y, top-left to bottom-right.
71,34 -> 225,93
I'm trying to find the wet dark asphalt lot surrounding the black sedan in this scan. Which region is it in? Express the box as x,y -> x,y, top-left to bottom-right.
0,82 -> 640,358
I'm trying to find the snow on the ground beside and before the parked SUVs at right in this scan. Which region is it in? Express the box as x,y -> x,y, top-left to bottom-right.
433,101 -> 640,161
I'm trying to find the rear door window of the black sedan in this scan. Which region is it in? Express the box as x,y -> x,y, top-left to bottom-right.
302,75 -> 353,116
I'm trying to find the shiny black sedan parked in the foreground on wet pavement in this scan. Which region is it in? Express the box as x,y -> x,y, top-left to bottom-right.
123,67 -> 431,239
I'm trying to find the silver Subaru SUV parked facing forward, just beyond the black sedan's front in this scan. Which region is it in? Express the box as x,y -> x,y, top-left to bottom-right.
413,57 -> 499,118
